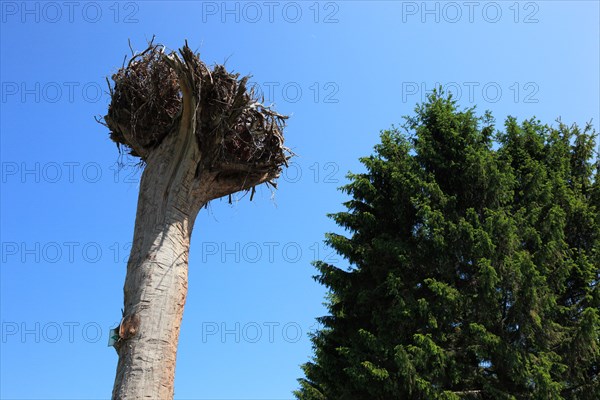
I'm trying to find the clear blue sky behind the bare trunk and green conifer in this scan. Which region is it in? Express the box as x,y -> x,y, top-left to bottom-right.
0,1 -> 600,399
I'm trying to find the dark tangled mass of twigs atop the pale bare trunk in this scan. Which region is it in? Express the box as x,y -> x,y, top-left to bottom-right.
104,43 -> 292,195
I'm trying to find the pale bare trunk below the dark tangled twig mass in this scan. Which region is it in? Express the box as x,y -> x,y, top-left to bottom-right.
113,126 -> 206,399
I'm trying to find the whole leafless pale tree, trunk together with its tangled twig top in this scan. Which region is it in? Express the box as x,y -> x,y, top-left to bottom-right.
102,41 -> 291,399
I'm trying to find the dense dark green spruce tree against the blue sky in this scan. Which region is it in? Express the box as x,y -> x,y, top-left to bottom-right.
295,91 -> 600,400
